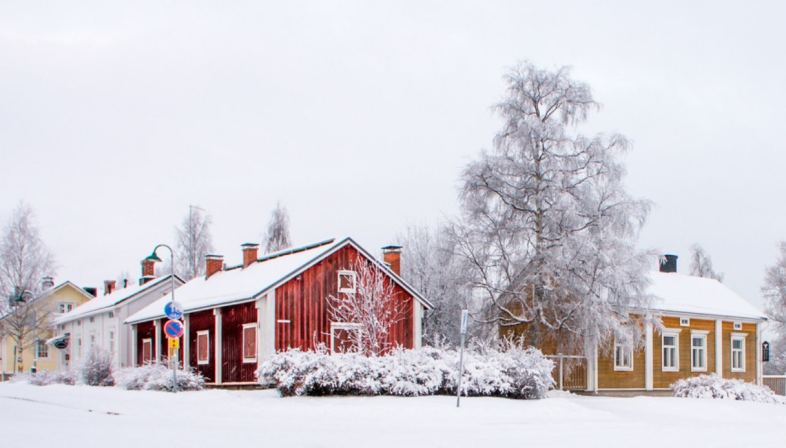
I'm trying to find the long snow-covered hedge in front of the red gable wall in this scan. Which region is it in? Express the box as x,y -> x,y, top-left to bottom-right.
258,344 -> 554,398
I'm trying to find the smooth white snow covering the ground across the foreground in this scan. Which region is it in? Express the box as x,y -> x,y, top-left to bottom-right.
0,383 -> 786,448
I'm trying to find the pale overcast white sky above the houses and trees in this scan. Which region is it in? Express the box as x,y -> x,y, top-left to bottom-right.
0,1 -> 786,310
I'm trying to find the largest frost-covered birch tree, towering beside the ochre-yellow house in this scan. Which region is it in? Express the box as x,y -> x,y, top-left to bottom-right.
453,63 -> 649,352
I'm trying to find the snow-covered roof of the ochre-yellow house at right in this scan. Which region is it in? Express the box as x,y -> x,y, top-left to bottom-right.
648,272 -> 766,320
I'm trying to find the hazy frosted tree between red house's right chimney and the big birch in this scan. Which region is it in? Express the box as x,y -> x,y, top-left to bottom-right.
397,226 -> 472,345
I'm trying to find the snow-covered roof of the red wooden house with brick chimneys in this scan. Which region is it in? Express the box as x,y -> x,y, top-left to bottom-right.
126,238 -> 431,323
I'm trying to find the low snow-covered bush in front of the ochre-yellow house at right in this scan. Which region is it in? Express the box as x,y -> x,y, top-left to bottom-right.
672,374 -> 786,404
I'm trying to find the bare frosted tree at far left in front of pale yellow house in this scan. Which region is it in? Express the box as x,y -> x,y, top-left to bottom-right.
0,203 -> 54,369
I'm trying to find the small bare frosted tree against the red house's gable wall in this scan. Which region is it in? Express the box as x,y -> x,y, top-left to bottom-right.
328,259 -> 407,355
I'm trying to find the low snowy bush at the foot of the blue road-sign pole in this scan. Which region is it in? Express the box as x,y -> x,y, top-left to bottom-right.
115,364 -> 205,391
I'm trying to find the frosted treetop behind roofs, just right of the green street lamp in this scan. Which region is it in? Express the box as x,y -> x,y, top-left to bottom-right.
174,205 -> 213,280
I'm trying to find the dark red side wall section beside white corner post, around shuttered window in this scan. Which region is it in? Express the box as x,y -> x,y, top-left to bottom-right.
221,302 -> 257,383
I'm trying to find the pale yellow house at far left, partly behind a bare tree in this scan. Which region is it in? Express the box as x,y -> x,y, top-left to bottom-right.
0,277 -> 93,379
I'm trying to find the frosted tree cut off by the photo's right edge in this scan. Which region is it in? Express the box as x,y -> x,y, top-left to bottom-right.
761,241 -> 786,375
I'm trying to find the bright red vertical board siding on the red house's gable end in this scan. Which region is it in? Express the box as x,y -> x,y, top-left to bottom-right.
275,246 -> 414,351
